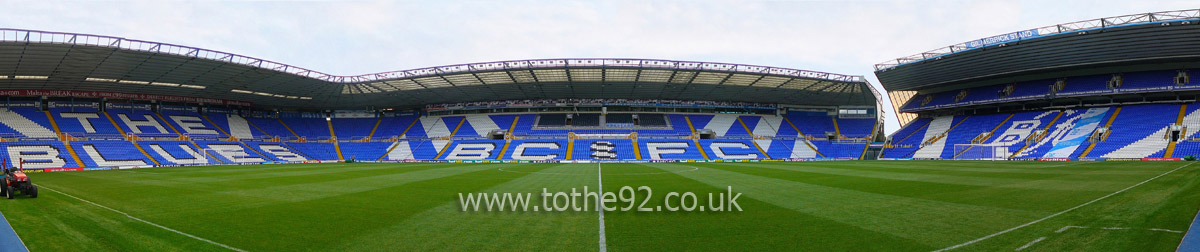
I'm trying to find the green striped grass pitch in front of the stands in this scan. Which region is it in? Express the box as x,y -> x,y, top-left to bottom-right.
0,161 -> 1200,251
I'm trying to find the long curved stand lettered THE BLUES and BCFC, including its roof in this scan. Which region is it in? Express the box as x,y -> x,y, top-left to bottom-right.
0,29 -> 882,170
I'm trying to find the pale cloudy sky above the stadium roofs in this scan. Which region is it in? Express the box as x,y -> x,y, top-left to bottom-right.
0,0 -> 1200,132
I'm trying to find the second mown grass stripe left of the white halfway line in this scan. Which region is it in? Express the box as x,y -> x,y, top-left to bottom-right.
178,164 -> 552,251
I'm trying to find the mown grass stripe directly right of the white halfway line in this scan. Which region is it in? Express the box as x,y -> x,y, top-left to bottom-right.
580,163 -> 934,251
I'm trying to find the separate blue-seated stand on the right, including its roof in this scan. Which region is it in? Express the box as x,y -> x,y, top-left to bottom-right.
875,10 -> 1200,160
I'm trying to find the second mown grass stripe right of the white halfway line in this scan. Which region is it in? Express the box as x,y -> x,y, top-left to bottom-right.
662,162 -> 1045,246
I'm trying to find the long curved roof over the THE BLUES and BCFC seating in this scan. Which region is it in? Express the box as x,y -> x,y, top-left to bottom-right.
0,29 -> 878,109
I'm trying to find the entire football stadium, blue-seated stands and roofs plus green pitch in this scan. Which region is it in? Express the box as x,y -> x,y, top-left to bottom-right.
0,3 -> 1200,251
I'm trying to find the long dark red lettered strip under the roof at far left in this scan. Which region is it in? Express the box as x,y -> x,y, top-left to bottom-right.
0,89 -> 254,107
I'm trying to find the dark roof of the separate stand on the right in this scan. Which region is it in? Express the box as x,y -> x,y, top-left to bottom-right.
875,10 -> 1200,92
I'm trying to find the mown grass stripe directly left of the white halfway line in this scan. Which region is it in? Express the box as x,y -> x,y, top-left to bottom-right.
328,163 -> 608,251
